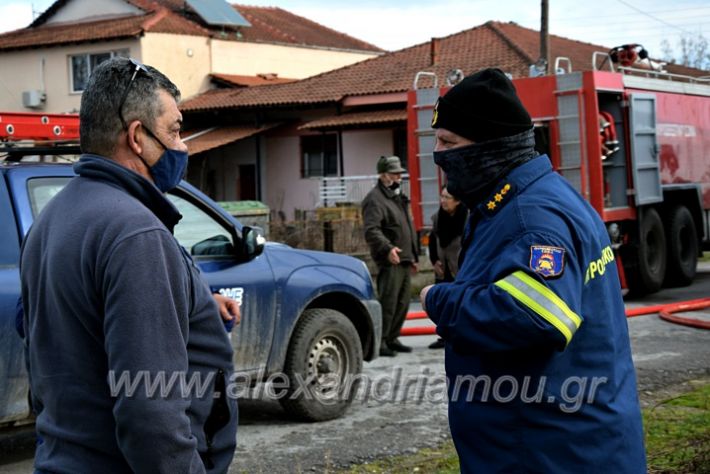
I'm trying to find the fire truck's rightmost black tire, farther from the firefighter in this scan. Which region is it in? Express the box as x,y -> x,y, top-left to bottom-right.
664,206 -> 698,286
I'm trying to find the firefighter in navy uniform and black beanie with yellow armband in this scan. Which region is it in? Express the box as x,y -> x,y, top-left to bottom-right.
421,69 -> 646,474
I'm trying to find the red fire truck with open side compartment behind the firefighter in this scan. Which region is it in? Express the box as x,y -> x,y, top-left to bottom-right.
408,57 -> 710,293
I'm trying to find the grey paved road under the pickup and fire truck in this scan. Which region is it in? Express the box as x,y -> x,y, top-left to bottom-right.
0,264 -> 710,474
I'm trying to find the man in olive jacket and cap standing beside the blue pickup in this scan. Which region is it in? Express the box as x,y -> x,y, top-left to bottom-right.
362,156 -> 418,357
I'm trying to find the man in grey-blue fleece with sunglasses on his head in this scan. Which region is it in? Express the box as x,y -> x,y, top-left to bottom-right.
21,58 -> 237,473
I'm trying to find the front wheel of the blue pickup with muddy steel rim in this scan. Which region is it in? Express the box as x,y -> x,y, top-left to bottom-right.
280,308 -> 362,421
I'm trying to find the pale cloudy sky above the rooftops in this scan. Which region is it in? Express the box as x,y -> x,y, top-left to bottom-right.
0,0 -> 710,64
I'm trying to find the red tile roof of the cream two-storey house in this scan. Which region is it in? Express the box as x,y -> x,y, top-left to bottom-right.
0,0 -> 382,52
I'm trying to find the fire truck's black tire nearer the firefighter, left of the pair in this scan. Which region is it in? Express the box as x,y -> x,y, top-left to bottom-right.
623,208 -> 667,295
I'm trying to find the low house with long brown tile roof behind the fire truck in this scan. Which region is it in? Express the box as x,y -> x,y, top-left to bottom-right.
181,21 -> 706,219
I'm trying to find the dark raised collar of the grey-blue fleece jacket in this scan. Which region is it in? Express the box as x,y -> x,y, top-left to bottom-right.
74,153 -> 182,233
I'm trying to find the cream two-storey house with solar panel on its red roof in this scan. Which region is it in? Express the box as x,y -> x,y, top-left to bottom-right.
0,0 -> 382,113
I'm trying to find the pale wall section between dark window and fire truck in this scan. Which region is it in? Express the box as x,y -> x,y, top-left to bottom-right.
343,129 -> 394,176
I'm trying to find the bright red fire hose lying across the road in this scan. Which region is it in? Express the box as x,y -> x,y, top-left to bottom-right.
400,298 -> 710,336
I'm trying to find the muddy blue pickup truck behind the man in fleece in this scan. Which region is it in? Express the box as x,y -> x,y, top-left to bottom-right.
0,161 -> 382,427
